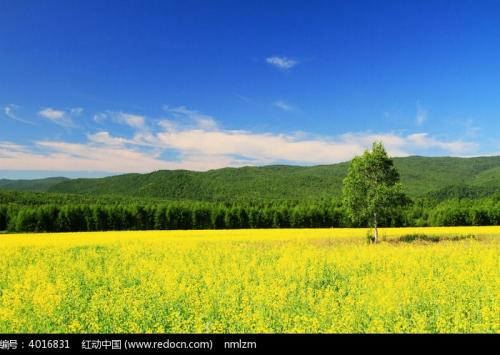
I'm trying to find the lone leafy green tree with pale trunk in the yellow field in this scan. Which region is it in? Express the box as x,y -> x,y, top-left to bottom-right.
342,142 -> 408,243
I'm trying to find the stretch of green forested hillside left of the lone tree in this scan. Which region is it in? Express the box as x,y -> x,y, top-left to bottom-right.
49,164 -> 347,201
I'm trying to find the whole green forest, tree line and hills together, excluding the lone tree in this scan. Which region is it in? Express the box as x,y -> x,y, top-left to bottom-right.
0,157 -> 500,232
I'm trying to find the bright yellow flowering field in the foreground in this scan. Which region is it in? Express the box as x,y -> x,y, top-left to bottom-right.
0,227 -> 500,333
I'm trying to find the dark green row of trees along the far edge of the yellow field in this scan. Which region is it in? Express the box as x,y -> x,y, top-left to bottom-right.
0,195 -> 500,232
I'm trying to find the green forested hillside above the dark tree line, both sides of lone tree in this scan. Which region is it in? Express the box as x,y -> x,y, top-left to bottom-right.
37,156 -> 500,201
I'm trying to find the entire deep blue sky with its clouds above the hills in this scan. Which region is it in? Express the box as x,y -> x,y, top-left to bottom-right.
0,0 -> 500,178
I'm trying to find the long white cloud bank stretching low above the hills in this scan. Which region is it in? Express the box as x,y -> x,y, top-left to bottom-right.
0,106 -> 479,173
